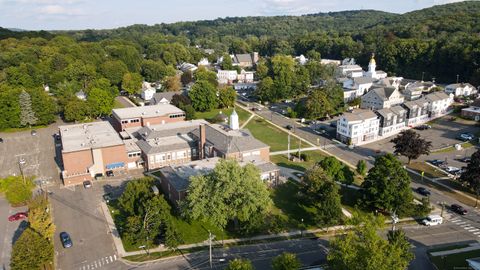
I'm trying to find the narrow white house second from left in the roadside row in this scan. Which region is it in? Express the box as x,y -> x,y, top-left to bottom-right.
375,105 -> 407,137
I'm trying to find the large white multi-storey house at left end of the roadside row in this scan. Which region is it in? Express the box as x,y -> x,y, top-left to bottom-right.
337,109 -> 380,145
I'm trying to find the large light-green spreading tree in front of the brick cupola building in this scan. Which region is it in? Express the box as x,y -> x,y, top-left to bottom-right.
182,160 -> 272,228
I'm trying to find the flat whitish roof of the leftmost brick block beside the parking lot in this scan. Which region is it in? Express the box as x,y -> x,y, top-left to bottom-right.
59,121 -> 124,152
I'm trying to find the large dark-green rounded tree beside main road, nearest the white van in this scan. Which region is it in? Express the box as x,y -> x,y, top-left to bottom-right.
362,154 -> 413,214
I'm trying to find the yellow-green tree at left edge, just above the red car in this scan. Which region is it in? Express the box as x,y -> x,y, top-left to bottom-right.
0,176 -> 35,206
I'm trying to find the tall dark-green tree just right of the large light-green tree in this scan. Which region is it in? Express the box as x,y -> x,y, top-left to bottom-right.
301,167 -> 343,226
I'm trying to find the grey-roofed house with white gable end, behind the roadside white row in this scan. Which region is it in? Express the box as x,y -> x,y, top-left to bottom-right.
360,87 -> 404,110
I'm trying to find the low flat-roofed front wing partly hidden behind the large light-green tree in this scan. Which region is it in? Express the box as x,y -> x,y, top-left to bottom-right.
157,157 -> 280,206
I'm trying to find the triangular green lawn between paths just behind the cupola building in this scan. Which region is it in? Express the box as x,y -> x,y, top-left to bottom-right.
246,117 -> 300,152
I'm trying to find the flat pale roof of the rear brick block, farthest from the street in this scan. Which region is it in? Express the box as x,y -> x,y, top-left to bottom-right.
112,104 -> 183,119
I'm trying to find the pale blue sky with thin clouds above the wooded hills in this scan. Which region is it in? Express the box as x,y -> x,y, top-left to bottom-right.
0,0 -> 466,30
